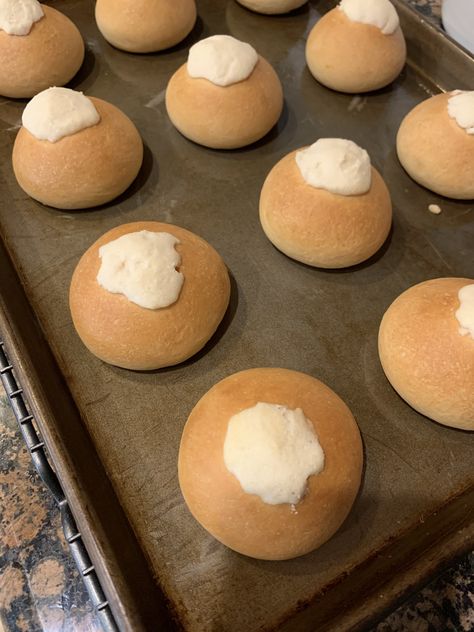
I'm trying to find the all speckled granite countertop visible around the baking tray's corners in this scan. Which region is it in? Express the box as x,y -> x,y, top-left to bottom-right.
0,0 -> 474,632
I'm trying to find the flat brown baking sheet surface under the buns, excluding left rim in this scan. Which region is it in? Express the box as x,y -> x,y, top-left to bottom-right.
0,0 -> 474,632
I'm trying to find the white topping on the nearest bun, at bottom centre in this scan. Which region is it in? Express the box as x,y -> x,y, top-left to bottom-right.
224,402 -> 324,505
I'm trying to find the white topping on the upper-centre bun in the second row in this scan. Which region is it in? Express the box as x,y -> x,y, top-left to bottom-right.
187,35 -> 258,87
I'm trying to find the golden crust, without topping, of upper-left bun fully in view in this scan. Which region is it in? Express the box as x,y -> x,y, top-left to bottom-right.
13,97 -> 143,210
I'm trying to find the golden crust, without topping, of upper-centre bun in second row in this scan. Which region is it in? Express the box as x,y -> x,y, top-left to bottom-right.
166,57 -> 283,149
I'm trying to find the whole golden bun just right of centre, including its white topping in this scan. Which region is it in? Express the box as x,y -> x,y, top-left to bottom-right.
260,139 -> 392,268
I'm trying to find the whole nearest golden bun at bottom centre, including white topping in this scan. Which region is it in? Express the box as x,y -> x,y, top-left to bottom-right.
178,369 -> 363,560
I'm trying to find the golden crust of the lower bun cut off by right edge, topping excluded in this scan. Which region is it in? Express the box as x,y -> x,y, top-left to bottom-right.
379,278 -> 474,430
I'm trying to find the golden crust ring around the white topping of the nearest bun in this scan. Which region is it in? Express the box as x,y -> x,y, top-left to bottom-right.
178,369 -> 363,560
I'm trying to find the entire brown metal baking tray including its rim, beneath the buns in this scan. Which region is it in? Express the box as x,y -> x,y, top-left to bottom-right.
0,0 -> 474,632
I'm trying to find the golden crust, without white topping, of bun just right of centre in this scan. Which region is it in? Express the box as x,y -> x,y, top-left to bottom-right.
260,150 -> 392,268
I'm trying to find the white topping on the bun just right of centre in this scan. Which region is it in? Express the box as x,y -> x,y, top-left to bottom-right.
296,138 -> 372,195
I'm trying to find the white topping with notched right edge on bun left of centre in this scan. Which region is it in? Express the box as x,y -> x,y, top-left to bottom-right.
97,230 -> 184,309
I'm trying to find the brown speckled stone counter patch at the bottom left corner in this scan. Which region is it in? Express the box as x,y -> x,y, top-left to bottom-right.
0,390 -> 101,632
